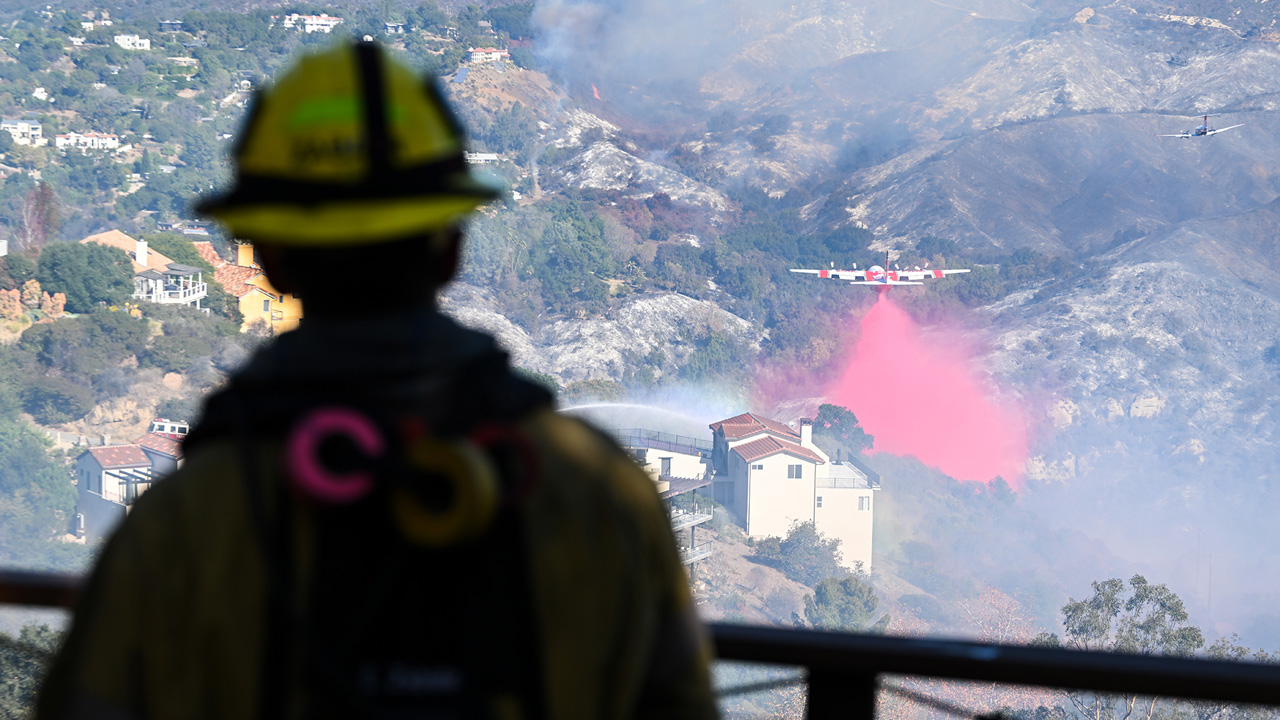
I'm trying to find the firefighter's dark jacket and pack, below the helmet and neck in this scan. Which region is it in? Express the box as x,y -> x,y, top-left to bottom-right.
37,311 -> 716,720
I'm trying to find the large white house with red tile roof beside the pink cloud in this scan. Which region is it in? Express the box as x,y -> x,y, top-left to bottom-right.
710,413 -> 879,571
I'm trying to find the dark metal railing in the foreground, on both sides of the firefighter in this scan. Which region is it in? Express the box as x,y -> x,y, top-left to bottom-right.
0,568 -> 1280,720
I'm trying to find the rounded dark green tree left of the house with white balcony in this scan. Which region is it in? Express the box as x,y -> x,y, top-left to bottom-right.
36,242 -> 133,313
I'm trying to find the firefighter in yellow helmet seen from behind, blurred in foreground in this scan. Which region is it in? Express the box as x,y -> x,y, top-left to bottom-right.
38,42 -> 716,720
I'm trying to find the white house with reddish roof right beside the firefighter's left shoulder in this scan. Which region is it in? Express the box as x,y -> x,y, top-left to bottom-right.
76,445 -> 155,539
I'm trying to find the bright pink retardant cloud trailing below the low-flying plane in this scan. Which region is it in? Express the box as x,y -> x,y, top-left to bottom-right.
831,295 -> 1027,487
